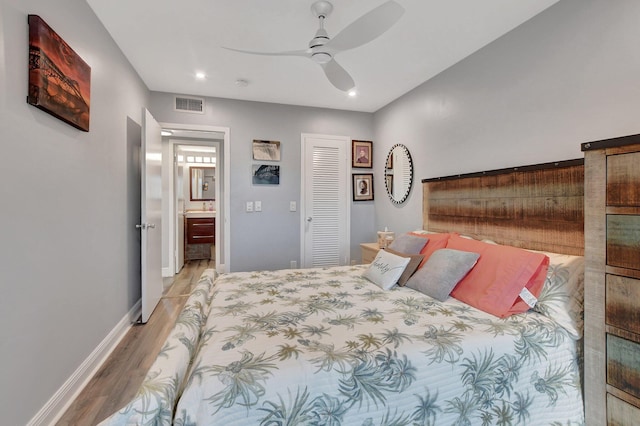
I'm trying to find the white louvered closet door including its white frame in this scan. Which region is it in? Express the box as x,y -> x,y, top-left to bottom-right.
300,134 -> 351,268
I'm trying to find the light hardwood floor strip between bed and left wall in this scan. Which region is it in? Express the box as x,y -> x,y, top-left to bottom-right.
57,260 -> 215,426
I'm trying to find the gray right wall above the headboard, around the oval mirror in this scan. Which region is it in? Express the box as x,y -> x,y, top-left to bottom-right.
374,0 -> 640,232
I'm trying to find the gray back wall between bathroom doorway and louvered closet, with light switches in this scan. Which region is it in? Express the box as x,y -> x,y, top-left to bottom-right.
150,92 -> 376,271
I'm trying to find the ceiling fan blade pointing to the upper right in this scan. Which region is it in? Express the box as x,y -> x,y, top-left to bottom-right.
326,0 -> 404,51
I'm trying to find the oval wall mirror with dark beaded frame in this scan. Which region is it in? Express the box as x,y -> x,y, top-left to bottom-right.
384,144 -> 413,204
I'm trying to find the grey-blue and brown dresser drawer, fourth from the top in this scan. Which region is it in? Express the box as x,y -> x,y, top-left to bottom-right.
607,334 -> 640,398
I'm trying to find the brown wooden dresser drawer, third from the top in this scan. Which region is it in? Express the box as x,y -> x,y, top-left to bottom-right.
605,274 -> 640,335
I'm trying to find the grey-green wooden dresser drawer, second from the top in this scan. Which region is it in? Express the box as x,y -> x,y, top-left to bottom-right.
607,214 -> 640,270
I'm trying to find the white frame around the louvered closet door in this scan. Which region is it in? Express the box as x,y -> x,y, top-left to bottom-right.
299,133 -> 351,267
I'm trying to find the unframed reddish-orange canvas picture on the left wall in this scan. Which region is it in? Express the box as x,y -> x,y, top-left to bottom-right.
27,15 -> 91,132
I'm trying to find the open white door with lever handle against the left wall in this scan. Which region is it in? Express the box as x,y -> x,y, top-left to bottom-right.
137,109 -> 163,323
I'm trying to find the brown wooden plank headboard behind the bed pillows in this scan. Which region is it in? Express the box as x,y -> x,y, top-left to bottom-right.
422,159 -> 584,255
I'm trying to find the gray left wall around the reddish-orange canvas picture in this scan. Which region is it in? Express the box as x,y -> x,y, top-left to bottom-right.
0,0 -> 149,425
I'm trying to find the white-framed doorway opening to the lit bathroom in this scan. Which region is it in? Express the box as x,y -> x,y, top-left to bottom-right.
161,123 -> 229,277
